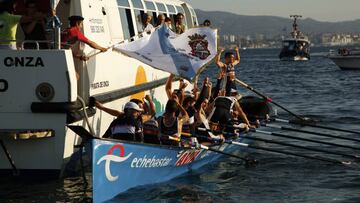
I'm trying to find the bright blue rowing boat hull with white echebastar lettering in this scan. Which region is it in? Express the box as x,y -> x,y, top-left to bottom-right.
92,135 -> 252,202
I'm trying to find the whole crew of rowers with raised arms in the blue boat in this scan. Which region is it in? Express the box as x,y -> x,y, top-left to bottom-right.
95,45 -> 256,146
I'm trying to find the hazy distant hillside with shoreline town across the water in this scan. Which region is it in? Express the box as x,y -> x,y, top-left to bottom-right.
196,9 -> 360,36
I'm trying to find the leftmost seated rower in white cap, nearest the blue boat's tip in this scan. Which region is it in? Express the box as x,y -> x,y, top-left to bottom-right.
103,102 -> 143,142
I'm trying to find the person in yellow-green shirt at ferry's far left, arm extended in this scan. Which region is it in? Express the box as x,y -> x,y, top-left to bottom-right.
0,0 -> 42,50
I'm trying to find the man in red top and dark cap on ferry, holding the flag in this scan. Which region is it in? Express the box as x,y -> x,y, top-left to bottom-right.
61,16 -> 108,61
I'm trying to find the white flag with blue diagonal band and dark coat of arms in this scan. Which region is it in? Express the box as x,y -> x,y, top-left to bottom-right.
114,26 -> 217,80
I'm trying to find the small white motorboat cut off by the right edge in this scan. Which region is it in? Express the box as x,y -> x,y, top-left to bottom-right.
328,48 -> 360,70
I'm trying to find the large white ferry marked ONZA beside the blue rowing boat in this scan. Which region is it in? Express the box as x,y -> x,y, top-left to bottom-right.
0,0 -> 198,174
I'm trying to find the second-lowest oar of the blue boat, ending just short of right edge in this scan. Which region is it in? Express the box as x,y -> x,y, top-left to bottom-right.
227,141 -> 351,165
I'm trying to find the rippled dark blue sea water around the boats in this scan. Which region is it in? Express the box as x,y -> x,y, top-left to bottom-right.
0,48 -> 360,202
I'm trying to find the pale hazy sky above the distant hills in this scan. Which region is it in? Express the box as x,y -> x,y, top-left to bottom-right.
182,0 -> 360,22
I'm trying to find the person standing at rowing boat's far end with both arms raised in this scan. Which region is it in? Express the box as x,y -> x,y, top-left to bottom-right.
215,47 -> 240,96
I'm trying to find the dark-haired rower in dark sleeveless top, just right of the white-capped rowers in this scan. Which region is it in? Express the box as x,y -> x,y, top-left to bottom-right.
158,97 -> 188,146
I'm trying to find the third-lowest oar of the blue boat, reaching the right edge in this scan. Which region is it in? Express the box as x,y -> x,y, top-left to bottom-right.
199,128 -> 360,159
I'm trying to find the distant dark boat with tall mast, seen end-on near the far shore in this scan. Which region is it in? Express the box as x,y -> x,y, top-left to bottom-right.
279,15 -> 310,61
